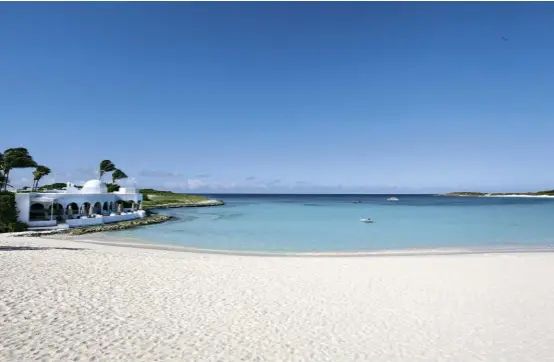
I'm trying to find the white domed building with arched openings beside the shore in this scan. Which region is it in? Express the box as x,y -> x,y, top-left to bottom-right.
15,180 -> 146,228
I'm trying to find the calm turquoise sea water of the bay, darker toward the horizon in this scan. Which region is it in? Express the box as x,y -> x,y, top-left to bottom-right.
103,195 -> 554,252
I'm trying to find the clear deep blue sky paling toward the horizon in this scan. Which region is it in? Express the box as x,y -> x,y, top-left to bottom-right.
0,2 -> 554,192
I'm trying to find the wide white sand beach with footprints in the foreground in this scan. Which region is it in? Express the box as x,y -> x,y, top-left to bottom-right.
0,236 -> 554,362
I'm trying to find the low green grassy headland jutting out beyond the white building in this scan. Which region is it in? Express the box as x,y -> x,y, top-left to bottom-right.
139,189 -> 224,209
